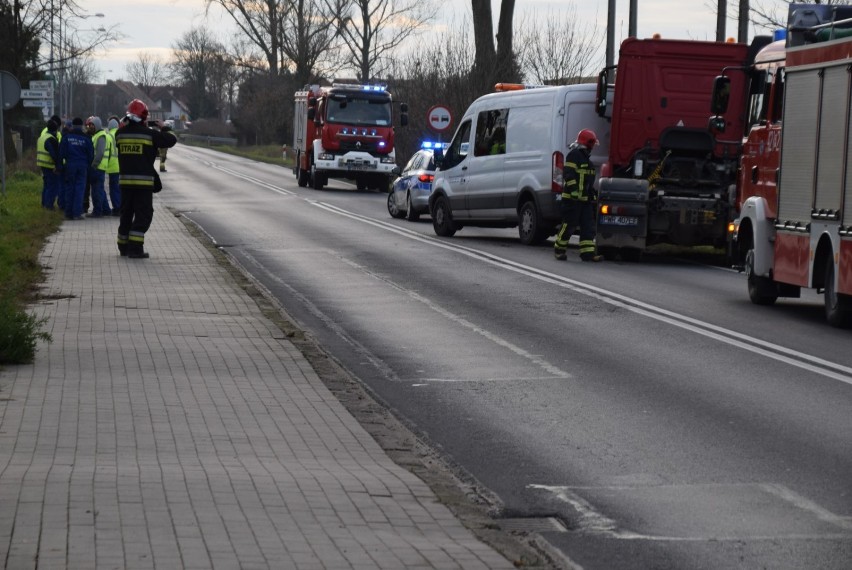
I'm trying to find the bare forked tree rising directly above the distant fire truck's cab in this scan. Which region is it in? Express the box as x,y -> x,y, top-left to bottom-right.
327,0 -> 437,81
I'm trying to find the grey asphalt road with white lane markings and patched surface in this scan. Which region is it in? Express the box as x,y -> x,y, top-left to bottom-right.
158,147 -> 852,569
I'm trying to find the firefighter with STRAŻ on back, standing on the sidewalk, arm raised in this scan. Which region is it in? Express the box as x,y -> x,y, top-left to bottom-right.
116,99 -> 177,259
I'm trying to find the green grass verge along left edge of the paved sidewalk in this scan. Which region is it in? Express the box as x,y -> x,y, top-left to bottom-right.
0,166 -> 63,364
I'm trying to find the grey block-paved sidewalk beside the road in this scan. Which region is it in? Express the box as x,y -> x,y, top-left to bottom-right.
0,206 -> 512,570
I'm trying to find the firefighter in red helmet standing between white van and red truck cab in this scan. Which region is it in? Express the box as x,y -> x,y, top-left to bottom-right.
553,129 -> 603,261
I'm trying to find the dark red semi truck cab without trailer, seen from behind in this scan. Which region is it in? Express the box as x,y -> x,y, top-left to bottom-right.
597,37 -> 770,259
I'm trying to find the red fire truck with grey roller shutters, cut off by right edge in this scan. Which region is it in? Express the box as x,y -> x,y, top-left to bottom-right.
712,4 -> 852,326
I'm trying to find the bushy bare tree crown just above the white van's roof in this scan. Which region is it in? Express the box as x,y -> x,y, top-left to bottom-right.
515,4 -> 601,85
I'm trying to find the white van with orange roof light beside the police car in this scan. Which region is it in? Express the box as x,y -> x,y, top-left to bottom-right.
429,83 -> 610,245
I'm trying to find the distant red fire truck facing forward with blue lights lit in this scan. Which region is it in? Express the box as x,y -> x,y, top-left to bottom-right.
293,83 -> 408,190
